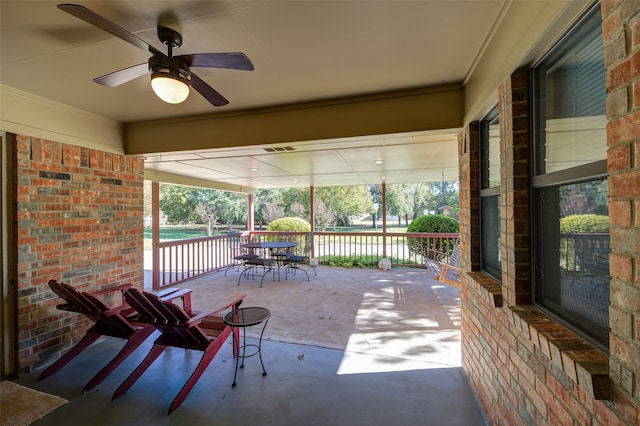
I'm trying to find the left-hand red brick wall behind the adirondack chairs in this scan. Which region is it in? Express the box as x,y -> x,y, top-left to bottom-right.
10,136 -> 144,372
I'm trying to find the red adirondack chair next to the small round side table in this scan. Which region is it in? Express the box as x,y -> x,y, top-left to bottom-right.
113,288 -> 245,414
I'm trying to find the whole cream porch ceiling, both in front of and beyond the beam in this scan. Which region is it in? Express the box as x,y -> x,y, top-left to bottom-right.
0,0 -> 510,188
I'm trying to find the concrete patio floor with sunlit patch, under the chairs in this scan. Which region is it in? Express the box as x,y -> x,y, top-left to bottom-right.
17,266 -> 486,425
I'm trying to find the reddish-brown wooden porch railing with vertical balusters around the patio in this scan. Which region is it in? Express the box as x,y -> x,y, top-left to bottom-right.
153,231 -> 459,289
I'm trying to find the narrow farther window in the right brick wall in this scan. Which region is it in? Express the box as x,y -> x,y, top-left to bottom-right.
480,107 -> 502,281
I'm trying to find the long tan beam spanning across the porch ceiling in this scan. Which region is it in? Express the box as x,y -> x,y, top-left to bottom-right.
124,84 -> 464,155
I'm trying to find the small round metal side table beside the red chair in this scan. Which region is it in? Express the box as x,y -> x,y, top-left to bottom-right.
224,307 -> 271,387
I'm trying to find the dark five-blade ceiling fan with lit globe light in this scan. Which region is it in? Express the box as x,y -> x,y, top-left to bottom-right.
58,4 -> 253,106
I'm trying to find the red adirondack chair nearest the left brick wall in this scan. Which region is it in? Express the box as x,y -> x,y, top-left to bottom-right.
38,280 -> 191,392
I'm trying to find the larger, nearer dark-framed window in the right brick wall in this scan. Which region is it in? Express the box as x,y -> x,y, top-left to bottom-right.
532,6 -> 610,348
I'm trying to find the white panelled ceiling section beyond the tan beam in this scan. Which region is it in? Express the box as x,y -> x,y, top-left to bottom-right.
145,127 -> 458,188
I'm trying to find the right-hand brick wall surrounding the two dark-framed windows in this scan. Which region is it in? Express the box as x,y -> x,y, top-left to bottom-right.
460,0 -> 640,425
